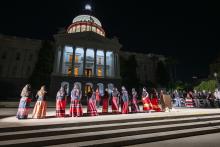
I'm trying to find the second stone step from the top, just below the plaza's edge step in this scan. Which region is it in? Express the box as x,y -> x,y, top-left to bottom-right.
0,116 -> 220,141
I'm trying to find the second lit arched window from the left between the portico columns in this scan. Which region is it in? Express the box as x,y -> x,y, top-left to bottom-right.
74,47 -> 84,76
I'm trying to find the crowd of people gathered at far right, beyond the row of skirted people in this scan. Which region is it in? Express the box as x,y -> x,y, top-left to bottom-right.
172,89 -> 220,108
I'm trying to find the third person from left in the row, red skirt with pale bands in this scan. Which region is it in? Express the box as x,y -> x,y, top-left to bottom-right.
56,86 -> 67,117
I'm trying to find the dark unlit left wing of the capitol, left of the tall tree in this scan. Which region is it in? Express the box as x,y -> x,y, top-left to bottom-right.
0,35 -> 41,98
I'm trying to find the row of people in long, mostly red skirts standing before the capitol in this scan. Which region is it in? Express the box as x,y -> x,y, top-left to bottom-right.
16,84 -> 165,119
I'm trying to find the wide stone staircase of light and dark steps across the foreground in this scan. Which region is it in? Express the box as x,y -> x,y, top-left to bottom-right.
0,113 -> 220,147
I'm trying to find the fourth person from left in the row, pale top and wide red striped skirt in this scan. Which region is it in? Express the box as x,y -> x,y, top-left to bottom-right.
70,84 -> 83,117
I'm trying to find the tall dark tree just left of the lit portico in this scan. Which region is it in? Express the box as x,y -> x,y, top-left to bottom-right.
29,41 -> 54,89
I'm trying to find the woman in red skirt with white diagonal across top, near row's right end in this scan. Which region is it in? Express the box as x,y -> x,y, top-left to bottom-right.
142,87 -> 152,112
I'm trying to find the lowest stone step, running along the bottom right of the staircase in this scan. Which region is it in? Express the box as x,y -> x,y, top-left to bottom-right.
50,126 -> 220,147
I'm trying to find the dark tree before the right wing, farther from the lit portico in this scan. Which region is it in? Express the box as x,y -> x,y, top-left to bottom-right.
156,61 -> 170,87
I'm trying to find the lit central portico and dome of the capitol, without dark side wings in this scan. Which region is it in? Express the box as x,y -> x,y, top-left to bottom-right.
50,4 -> 121,95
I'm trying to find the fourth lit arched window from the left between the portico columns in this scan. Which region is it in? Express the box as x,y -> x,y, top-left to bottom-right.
96,50 -> 104,77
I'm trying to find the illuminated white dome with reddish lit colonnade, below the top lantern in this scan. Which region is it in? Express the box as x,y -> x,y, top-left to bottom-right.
67,15 -> 105,36
